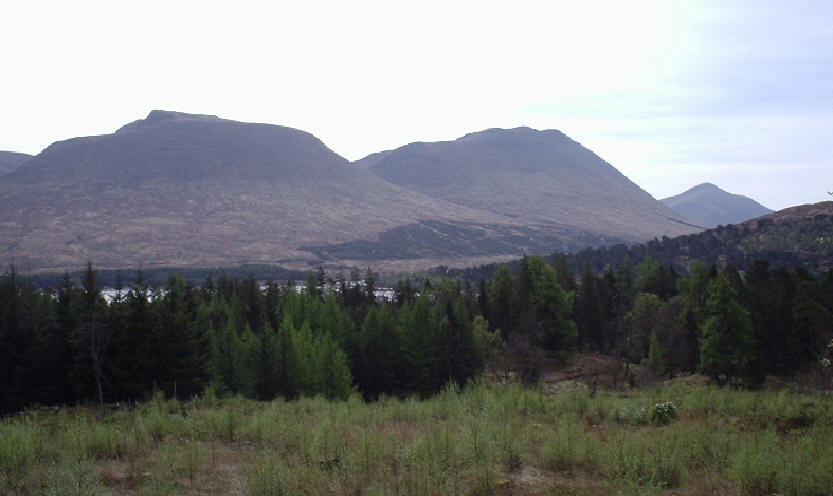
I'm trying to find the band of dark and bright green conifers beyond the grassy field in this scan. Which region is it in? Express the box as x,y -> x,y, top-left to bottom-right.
0,256 -> 833,412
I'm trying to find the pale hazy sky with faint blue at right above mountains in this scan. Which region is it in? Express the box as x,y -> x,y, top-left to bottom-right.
0,0 -> 833,209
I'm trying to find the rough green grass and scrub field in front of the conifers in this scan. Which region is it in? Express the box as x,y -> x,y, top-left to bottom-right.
0,384 -> 833,495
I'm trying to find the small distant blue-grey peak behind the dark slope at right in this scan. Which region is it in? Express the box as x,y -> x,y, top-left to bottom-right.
660,183 -> 772,227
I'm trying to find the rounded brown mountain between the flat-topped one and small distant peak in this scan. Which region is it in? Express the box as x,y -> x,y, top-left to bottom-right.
356,127 -> 700,242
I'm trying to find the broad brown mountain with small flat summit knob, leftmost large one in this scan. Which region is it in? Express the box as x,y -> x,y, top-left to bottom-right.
0,111 -> 509,271
